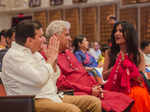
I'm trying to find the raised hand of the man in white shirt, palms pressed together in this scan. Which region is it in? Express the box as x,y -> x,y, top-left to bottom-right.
46,35 -> 60,66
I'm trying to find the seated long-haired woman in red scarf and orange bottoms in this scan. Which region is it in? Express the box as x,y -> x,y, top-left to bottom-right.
103,21 -> 150,112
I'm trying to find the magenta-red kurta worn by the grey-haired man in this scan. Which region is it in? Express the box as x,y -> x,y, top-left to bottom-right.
57,50 -> 133,112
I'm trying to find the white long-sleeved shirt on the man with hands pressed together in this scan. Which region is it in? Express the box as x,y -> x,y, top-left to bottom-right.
1,42 -> 62,102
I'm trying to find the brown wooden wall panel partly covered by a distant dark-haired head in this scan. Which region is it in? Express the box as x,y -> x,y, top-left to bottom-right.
100,4 -> 117,44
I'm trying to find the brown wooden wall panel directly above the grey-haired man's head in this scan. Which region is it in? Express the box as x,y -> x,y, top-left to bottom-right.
48,10 -> 63,24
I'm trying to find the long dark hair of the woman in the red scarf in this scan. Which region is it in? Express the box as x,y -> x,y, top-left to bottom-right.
109,21 -> 140,67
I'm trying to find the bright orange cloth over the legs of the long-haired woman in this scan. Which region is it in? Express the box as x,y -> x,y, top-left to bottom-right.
129,86 -> 150,112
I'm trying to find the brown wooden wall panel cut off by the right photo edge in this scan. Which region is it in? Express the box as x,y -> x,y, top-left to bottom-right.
141,6 -> 150,40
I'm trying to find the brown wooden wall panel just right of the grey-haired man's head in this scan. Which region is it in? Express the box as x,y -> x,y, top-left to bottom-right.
65,8 -> 80,39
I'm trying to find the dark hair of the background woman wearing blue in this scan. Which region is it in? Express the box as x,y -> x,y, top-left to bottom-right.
72,35 -> 86,52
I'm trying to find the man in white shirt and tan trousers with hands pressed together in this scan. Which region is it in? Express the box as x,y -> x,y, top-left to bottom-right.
2,21 -> 101,112
